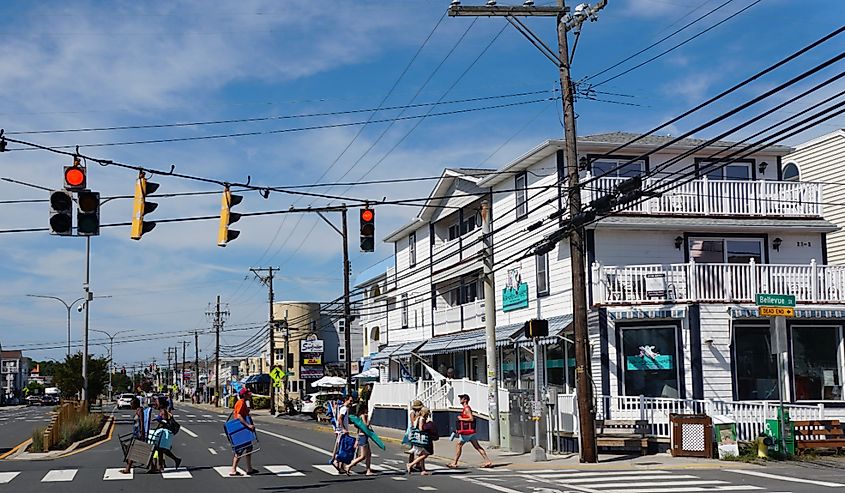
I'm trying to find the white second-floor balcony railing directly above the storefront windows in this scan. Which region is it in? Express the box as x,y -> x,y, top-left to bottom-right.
592,260 -> 845,305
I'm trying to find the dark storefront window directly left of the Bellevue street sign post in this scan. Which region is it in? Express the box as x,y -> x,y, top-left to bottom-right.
734,326 -> 779,401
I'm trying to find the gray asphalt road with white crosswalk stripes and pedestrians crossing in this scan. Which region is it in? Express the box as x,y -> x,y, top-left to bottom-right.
0,406 -> 845,493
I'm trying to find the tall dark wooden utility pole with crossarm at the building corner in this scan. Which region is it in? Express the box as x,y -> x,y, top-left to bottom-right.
449,0 -> 607,462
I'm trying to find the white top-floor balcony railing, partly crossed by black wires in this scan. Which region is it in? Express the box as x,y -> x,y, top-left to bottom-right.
584,176 -> 823,217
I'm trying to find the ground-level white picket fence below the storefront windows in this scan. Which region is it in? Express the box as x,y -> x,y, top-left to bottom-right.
557,394 -> 825,440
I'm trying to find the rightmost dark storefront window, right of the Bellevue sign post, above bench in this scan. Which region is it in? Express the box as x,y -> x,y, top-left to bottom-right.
792,325 -> 842,401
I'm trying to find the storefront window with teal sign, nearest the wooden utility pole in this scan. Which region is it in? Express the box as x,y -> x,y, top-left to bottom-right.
622,326 -> 679,398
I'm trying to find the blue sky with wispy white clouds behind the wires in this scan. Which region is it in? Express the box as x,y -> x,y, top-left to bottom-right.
0,0 -> 845,364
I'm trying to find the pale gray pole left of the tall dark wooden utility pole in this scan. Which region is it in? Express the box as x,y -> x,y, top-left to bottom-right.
481,199 -> 501,448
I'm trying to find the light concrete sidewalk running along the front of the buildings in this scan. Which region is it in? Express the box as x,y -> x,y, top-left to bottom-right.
181,403 -> 755,471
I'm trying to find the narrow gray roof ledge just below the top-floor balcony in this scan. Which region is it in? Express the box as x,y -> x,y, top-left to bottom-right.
594,215 -> 839,233
